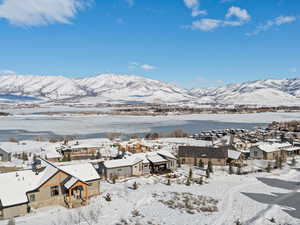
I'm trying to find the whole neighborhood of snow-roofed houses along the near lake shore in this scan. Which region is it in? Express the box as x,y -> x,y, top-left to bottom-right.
0,126 -> 300,219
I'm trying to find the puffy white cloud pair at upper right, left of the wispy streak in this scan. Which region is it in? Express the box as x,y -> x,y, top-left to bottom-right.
185,6 -> 251,31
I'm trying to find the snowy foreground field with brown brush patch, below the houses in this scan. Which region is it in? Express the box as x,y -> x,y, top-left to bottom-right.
0,164 -> 300,225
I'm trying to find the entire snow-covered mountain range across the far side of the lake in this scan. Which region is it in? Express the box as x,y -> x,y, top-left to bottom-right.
0,74 -> 300,105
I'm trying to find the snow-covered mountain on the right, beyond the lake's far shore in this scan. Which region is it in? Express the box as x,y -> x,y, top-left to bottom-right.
189,78 -> 300,105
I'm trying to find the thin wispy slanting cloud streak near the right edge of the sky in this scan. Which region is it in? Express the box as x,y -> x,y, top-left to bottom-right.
246,16 -> 297,36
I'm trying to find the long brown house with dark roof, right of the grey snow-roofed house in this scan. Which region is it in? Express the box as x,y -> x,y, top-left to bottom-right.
178,146 -> 230,166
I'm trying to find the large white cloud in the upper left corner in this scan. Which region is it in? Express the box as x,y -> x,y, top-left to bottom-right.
0,0 -> 92,26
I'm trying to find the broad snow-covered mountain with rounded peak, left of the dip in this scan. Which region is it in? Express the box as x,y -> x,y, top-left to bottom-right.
0,74 -> 194,103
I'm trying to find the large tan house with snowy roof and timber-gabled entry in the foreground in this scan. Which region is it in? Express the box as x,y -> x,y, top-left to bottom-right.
0,159 -> 100,219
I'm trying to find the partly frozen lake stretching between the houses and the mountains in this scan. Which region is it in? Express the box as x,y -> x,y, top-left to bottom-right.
0,113 -> 300,141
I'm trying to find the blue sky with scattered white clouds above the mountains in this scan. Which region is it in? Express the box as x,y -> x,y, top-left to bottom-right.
0,0 -> 300,88
